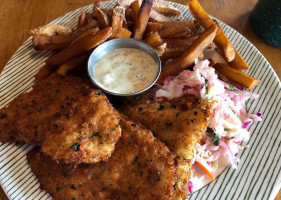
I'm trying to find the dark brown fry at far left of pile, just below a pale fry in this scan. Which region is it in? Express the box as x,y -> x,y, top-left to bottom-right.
32,35 -> 76,50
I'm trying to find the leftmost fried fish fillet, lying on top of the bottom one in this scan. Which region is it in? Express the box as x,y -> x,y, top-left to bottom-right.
0,75 -> 121,163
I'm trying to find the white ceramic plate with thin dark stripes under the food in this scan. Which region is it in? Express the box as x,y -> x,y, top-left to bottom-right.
0,1 -> 281,200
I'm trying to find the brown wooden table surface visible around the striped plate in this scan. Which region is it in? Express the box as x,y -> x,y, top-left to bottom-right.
0,0 -> 281,200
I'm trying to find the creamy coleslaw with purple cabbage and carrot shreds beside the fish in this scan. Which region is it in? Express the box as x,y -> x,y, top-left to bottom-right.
156,60 -> 262,193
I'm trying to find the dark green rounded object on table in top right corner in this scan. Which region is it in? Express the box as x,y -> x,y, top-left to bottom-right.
250,0 -> 281,48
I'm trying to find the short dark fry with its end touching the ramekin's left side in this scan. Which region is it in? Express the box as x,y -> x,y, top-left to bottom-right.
57,55 -> 89,76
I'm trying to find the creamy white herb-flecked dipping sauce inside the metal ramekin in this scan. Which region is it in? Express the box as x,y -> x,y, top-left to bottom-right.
94,48 -> 158,94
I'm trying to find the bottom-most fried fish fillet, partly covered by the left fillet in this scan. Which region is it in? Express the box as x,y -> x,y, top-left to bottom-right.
27,119 -> 177,200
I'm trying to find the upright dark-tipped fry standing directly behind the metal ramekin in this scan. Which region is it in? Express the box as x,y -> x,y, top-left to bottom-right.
133,0 -> 153,40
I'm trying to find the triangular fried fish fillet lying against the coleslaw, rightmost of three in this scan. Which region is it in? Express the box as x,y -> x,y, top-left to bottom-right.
121,96 -> 211,199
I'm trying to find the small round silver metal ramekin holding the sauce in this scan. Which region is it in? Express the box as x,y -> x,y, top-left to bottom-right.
88,38 -> 161,96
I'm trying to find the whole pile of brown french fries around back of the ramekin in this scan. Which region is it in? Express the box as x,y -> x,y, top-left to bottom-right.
30,0 -> 259,89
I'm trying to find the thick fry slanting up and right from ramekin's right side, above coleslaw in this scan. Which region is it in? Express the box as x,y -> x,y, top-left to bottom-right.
157,25 -> 217,84
